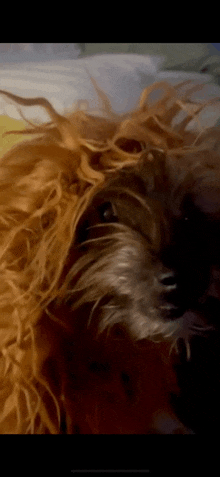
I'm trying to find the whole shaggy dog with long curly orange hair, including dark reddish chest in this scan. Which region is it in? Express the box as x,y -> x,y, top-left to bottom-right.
0,83 -> 220,434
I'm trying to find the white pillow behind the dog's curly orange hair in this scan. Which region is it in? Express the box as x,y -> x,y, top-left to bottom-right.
0,54 -> 220,127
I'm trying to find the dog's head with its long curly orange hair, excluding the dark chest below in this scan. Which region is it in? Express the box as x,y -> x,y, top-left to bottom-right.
0,85 -> 219,432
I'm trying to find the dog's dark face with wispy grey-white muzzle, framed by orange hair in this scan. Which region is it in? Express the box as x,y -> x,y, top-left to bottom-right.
53,150 -> 219,339
